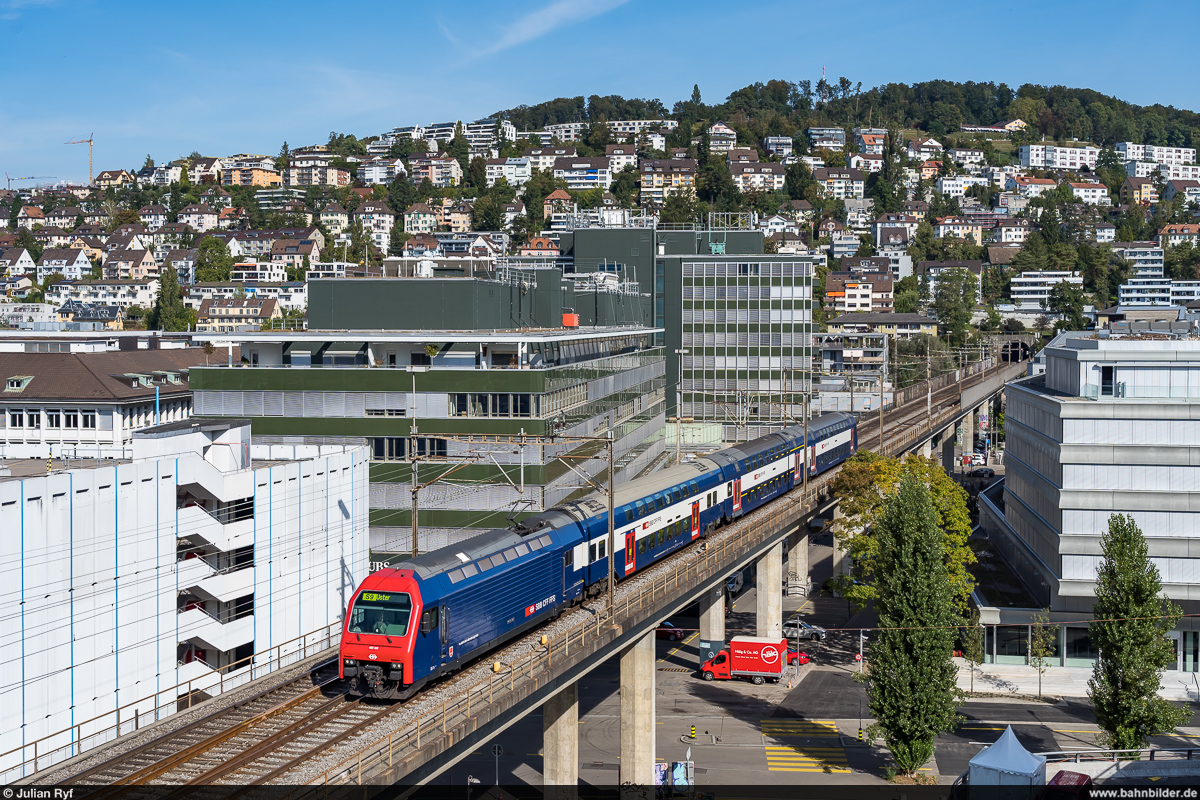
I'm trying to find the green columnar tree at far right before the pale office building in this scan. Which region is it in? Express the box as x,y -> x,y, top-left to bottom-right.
1087,515 -> 1192,750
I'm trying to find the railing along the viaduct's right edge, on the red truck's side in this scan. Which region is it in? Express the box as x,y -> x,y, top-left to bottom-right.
310,405 -> 960,784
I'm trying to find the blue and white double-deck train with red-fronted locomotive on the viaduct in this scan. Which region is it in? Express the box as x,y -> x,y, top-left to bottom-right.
340,414 -> 858,699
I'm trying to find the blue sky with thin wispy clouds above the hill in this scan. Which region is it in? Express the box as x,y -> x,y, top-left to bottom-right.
0,0 -> 1200,181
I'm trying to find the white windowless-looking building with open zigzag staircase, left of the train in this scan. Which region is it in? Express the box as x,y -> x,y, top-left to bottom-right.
0,419 -> 368,769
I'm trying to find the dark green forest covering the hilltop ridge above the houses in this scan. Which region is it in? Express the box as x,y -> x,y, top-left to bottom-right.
497,78 -> 1200,148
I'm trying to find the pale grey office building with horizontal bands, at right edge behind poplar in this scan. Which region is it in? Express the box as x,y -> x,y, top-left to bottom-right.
980,340 -> 1200,682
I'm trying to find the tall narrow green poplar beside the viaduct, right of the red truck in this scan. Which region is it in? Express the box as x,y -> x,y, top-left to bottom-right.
868,476 -> 961,775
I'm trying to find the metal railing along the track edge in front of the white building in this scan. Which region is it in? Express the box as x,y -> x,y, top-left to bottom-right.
0,620 -> 342,783
